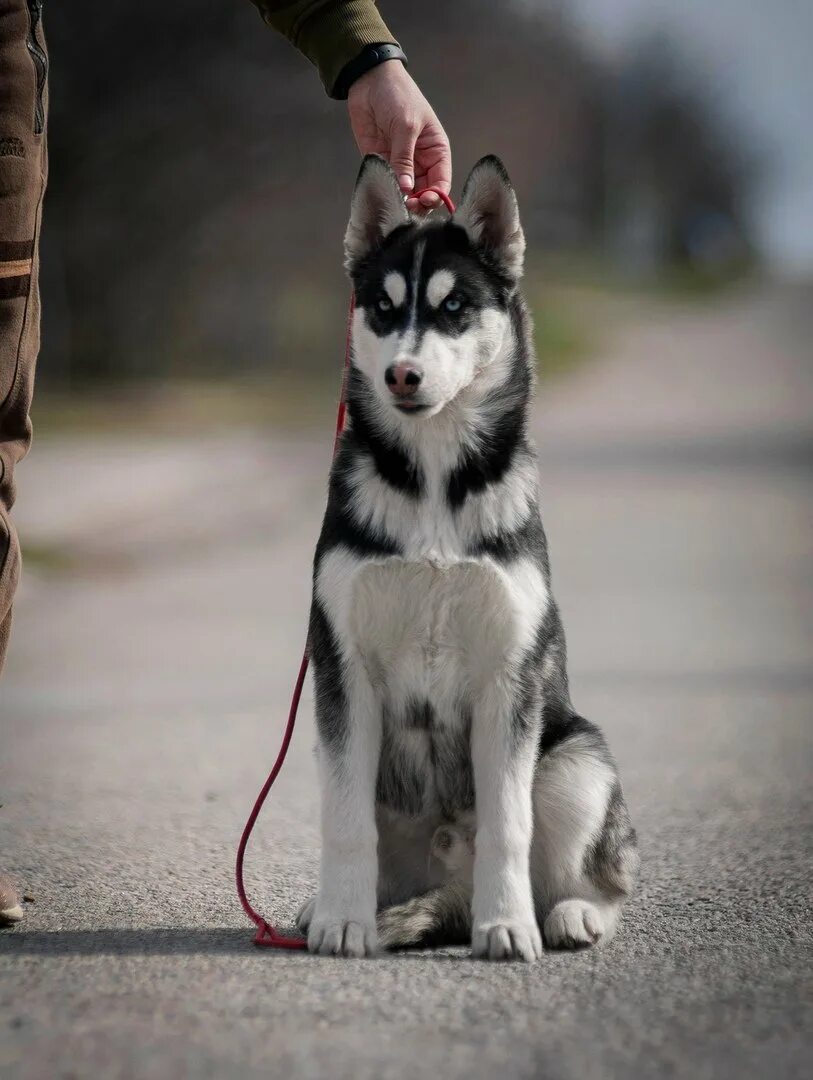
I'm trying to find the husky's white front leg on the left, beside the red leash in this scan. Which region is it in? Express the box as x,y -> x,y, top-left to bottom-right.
308,662 -> 381,957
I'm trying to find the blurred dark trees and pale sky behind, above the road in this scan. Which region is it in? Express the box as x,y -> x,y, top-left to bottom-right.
40,0 -> 813,406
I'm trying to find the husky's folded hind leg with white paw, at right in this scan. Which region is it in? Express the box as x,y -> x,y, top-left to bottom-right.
531,716 -> 638,948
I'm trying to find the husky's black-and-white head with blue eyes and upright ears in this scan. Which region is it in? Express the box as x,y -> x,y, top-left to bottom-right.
344,154 -> 525,417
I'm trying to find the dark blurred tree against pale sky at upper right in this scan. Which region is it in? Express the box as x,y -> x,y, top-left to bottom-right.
606,35 -> 754,274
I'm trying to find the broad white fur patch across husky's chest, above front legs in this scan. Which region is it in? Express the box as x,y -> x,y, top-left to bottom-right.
316,549 -> 547,707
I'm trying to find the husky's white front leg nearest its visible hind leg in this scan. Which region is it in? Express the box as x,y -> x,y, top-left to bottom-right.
472,681 -> 542,960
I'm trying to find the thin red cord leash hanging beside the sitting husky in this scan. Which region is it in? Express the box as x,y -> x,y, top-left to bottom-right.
235,188 -> 455,948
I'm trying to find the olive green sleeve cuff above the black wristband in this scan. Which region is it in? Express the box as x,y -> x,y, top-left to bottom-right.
253,0 -> 397,96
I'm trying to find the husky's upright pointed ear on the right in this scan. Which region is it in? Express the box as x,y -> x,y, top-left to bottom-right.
452,154 -> 525,281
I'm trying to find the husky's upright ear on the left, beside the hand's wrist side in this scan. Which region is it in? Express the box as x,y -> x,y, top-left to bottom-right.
344,153 -> 409,271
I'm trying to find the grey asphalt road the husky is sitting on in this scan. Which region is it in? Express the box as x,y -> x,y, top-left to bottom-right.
0,291 -> 813,1080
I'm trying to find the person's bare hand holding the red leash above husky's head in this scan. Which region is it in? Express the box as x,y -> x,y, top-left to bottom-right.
348,60 -> 451,211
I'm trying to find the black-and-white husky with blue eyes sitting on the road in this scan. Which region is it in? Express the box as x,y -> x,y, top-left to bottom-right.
298,156 -> 637,960
